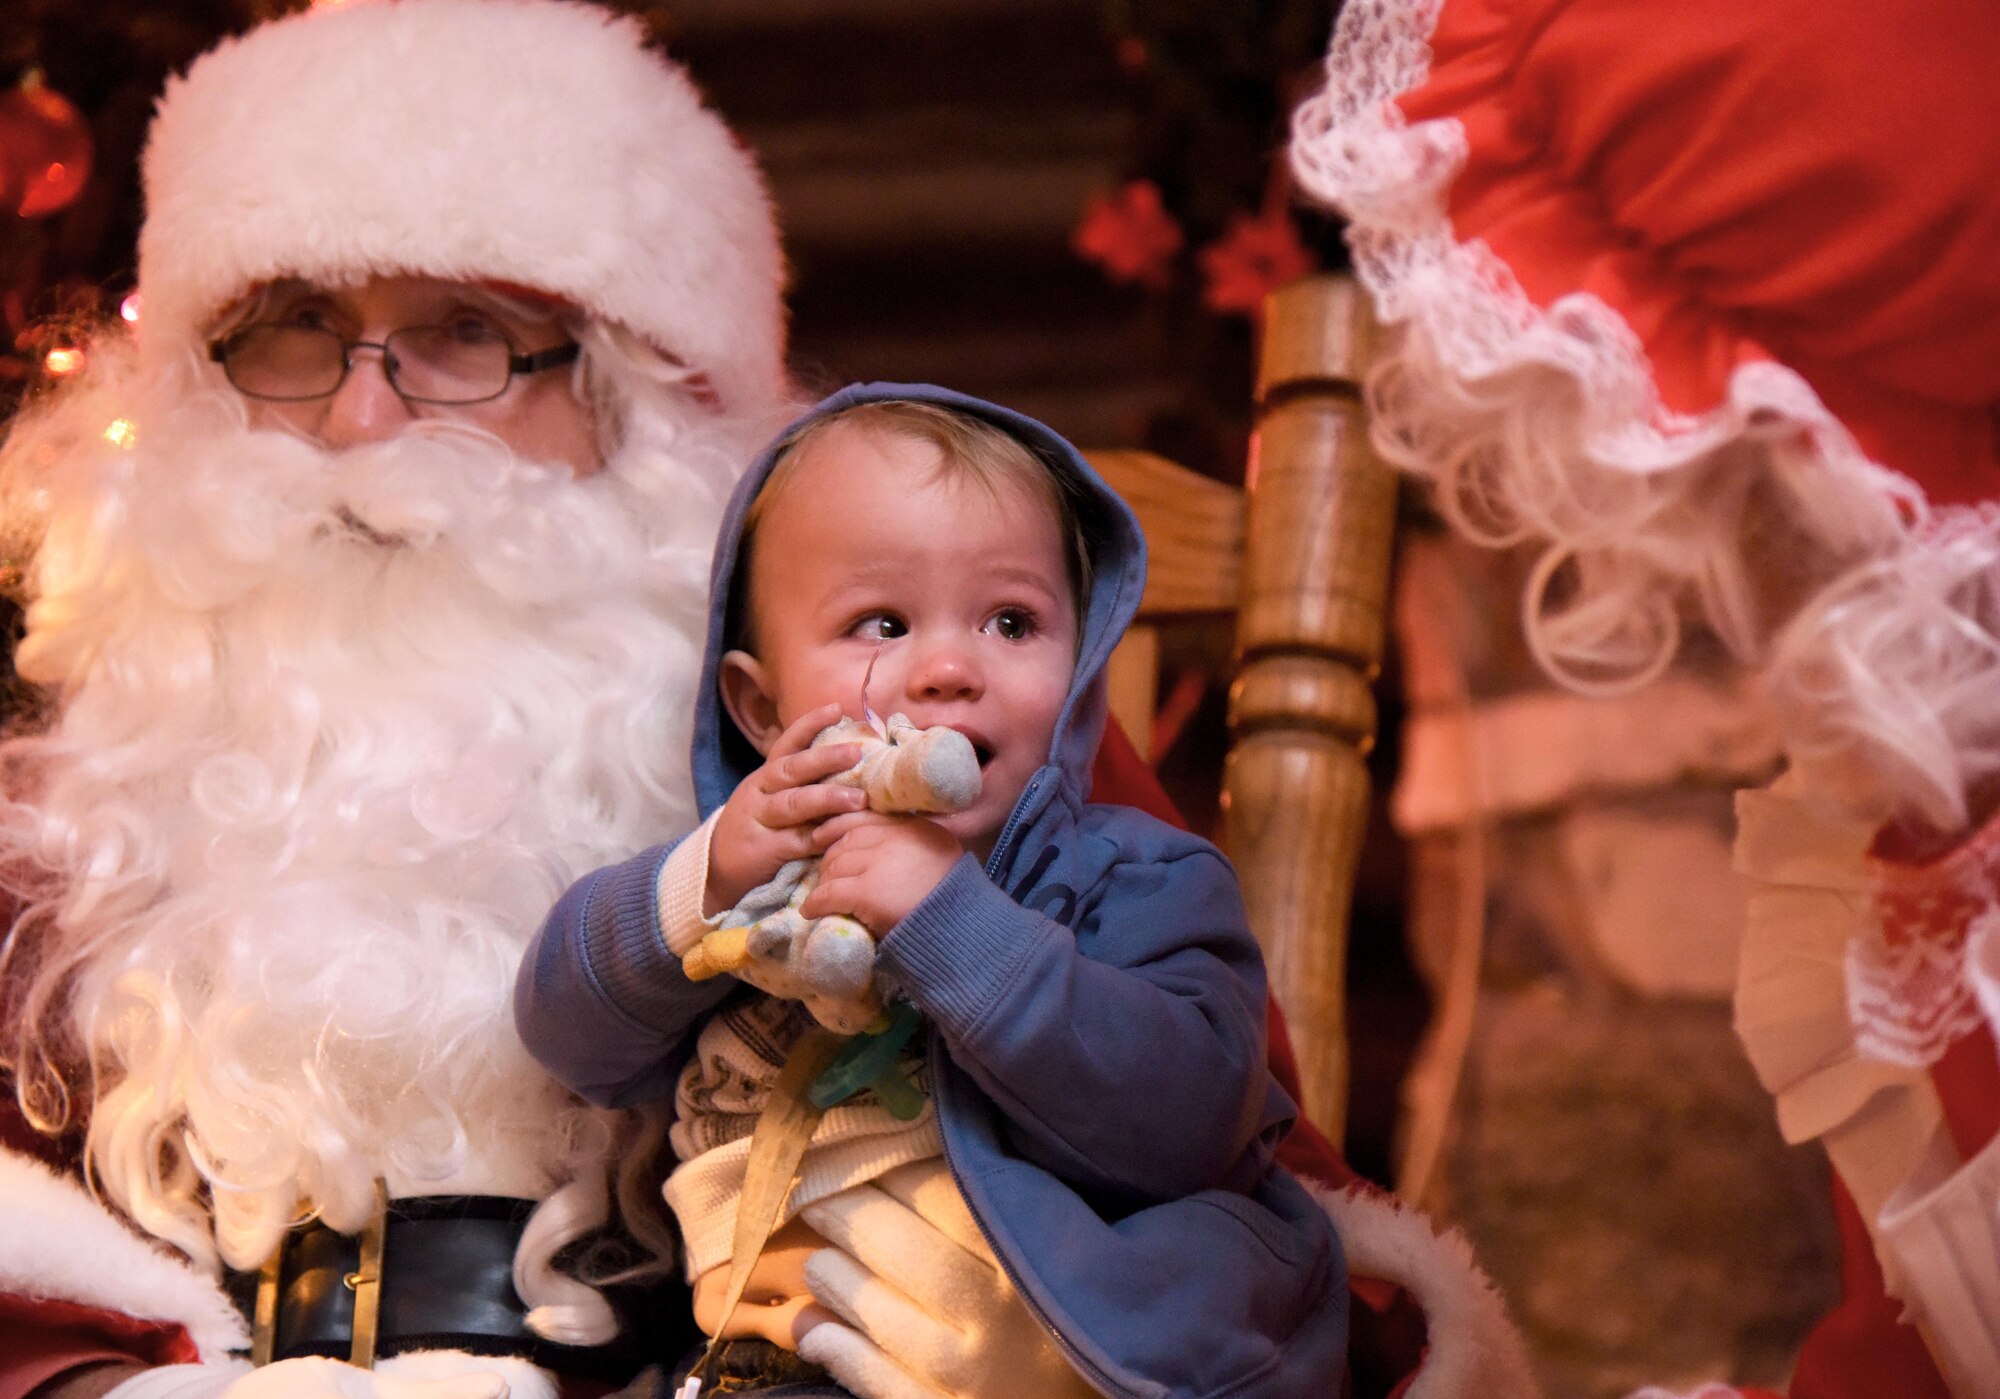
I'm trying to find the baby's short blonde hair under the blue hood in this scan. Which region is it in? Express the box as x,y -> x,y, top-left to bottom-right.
728,398 -> 1092,642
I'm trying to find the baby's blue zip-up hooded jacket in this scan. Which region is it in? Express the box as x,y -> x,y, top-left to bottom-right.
516,384 -> 1348,1399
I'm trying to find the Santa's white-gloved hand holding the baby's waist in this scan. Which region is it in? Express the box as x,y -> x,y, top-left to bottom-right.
798,1161 -> 1096,1399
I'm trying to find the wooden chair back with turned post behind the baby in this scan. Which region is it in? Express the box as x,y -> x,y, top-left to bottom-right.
1090,274 -> 1396,1143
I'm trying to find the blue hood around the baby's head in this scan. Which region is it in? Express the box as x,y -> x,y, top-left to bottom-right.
694,384 -> 1146,819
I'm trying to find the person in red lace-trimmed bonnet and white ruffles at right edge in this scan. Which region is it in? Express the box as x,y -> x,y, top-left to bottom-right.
1294,0 -> 2000,1399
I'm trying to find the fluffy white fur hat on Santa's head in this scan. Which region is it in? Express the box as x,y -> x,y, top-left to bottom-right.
138,0 -> 784,410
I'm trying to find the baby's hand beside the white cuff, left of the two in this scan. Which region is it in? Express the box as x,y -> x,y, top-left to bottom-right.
702,703 -> 868,917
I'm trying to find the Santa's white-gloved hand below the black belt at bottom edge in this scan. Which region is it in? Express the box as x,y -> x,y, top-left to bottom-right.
106,1353 -> 532,1399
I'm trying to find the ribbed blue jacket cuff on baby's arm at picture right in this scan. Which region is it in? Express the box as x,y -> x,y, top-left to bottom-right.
880,855 -> 1054,1035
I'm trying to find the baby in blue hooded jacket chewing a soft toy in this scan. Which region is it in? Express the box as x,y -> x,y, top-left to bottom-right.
516,386 -> 1346,1397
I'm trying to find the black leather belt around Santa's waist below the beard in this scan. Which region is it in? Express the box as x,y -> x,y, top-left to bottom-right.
228,1195 -> 700,1383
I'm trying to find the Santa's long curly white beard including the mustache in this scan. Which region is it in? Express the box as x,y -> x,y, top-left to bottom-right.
0,371 -> 740,1267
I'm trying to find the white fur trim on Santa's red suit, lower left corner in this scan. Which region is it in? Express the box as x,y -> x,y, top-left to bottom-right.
0,1149 -> 250,1361
